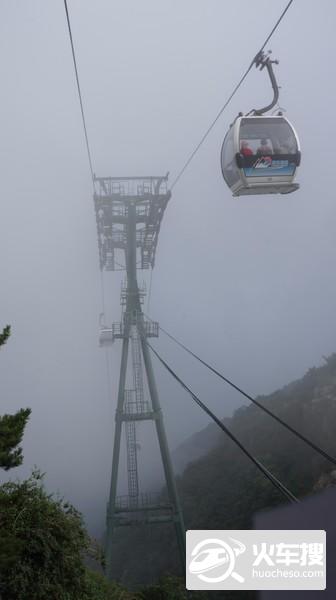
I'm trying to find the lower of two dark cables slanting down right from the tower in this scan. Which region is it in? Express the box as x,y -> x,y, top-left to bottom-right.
146,340 -> 299,502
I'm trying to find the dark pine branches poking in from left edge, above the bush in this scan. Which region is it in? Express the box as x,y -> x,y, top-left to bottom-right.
0,325 -> 31,471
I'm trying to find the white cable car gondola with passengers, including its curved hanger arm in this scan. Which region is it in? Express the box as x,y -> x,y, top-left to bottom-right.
221,53 -> 301,196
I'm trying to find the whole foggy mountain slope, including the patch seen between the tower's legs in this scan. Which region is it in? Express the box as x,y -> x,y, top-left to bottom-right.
111,354 -> 336,599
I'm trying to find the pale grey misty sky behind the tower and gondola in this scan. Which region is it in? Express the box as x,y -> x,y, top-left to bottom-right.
0,0 -> 336,536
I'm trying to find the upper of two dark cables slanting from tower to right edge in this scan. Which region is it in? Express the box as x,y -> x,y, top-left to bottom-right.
146,315 -> 336,465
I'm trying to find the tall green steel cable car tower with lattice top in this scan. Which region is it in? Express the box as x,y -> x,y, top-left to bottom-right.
94,175 -> 185,579
